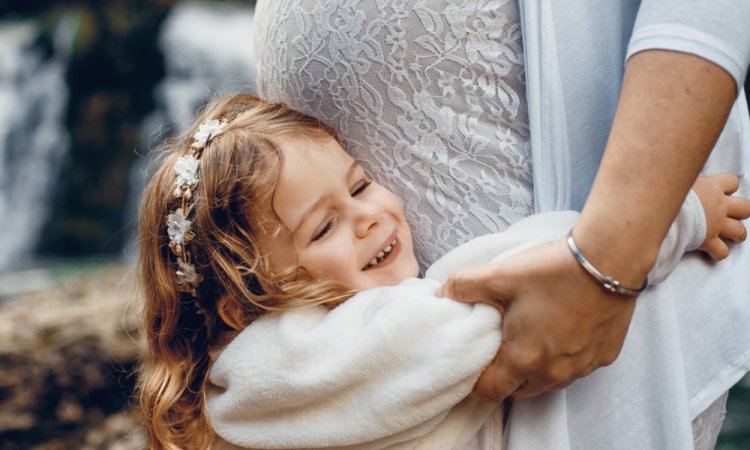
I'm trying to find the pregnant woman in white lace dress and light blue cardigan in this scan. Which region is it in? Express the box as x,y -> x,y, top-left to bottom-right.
255,0 -> 750,449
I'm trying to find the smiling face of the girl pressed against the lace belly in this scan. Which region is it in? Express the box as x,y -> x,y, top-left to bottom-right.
268,137 -> 419,290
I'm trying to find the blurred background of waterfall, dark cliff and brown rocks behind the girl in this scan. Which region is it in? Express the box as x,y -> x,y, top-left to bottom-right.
0,0 -> 750,450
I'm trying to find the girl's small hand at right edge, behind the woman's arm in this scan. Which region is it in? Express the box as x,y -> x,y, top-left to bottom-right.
693,173 -> 750,261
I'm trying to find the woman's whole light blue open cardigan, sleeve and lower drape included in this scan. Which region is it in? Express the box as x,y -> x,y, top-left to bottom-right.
506,0 -> 750,450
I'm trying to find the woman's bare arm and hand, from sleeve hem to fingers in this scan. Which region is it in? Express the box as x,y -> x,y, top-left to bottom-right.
443,50 -> 736,400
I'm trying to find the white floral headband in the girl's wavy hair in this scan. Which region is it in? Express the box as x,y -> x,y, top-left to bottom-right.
167,119 -> 229,297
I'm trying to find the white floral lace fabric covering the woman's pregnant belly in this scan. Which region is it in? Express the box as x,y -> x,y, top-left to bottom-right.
255,0 -> 533,266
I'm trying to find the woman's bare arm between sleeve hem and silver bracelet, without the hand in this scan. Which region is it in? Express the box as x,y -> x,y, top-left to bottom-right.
575,50 -> 736,286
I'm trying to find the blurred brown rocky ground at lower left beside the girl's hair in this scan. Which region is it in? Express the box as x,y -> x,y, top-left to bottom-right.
0,266 -> 145,450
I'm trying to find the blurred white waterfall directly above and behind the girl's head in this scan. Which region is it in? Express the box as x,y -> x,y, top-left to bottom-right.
125,2 -> 255,261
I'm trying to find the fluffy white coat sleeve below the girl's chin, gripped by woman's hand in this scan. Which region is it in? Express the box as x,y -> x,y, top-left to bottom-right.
207,279 -> 500,448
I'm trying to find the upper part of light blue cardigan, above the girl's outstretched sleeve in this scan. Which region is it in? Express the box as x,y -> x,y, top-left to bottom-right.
520,0 -> 750,212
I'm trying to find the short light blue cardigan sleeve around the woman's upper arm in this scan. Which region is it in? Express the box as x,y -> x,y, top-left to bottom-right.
627,0 -> 750,93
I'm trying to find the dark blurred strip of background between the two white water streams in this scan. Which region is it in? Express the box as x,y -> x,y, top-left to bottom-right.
39,0 -> 174,256
